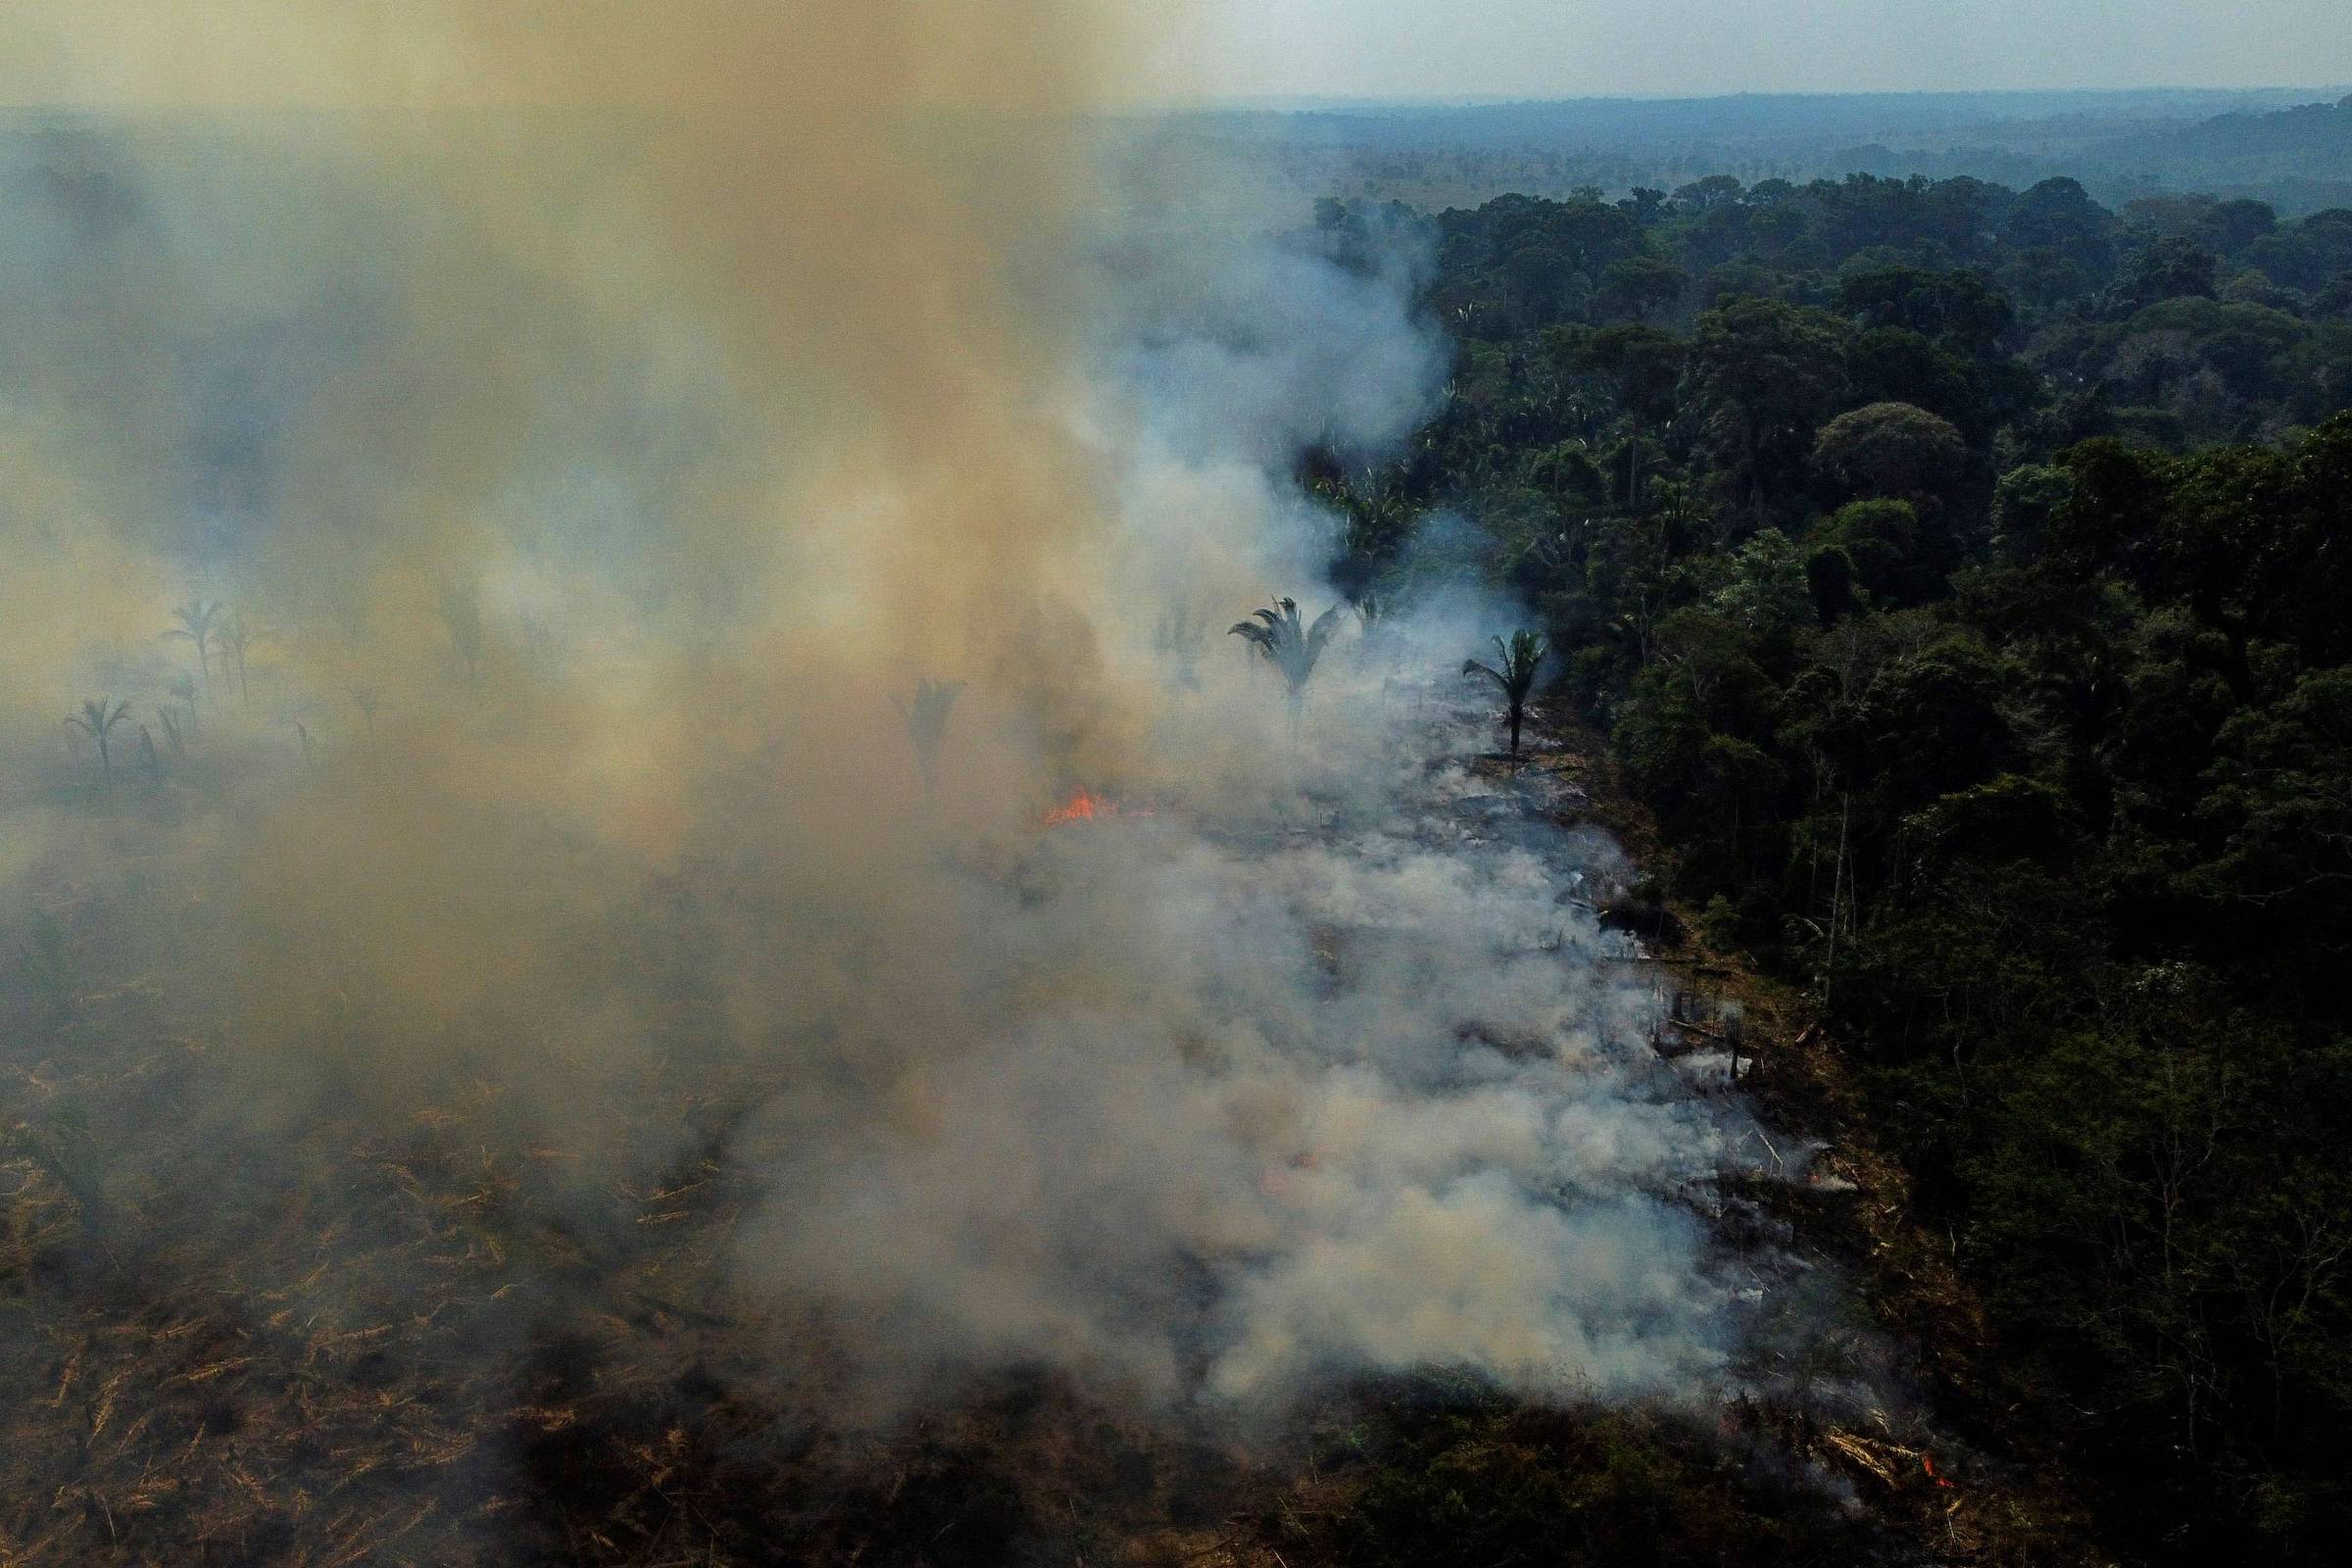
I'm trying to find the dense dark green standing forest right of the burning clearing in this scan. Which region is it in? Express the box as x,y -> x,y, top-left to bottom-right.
1305,166 -> 2352,1561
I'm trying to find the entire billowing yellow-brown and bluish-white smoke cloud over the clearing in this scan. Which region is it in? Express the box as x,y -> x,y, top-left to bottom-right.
0,0 -> 1768,1494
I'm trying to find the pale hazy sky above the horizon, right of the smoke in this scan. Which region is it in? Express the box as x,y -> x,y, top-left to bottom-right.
1176,0 -> 2352,99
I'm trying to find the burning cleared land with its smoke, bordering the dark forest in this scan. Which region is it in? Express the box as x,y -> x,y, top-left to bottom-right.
0,0 -> 2117,1568
